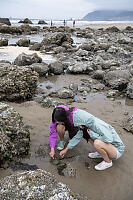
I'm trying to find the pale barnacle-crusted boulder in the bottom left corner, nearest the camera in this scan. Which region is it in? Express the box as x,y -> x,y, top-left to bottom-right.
0,169 -> 88,200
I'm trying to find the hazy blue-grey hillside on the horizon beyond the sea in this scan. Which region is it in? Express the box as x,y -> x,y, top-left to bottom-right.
82,10 -> 133,21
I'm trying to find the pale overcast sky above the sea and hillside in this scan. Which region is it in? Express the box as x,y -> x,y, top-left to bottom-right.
0,0 -> 133,19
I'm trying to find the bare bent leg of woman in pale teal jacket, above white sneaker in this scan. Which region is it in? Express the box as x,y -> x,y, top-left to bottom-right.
93,139 -> 117,163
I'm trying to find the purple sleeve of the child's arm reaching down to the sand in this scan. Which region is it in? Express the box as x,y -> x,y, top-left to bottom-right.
50,121 -> 58,148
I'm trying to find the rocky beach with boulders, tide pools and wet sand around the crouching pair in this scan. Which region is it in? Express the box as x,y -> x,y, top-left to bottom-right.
0,19 -> 133,200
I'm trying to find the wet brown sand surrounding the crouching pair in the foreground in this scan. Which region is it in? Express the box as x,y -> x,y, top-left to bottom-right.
0,86 -> 133,200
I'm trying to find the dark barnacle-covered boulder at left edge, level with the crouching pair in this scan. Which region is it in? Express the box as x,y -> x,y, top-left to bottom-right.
0,103 -> 30,163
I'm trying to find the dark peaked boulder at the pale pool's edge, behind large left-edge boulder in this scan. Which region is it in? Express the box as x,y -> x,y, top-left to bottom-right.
14,53 -> 42,66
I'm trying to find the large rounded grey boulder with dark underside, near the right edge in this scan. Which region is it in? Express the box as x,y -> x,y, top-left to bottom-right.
104,70 -> 131,91
